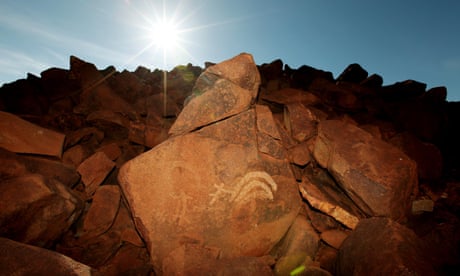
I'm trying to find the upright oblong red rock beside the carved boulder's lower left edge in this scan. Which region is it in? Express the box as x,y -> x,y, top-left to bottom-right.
83,185 -> 120,236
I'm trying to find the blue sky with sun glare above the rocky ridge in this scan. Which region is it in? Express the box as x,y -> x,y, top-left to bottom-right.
0,0 -> 460,101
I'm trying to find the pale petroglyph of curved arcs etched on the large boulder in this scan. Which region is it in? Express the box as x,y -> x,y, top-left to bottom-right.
210,171 -> 278,205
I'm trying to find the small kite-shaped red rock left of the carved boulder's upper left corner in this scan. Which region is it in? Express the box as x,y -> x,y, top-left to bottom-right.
77,151 -> 115,196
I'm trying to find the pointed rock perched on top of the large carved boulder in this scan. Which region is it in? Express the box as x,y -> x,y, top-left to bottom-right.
169,54 -> 260,135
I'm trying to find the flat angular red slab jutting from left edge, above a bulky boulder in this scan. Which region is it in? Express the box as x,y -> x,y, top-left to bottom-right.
0,111 -> 65,158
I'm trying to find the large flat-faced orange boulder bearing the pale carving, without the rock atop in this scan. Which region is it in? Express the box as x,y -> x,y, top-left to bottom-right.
118,109 -> 301,271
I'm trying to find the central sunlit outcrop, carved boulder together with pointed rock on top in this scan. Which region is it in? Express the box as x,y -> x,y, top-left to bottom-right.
118,54 -> 300,274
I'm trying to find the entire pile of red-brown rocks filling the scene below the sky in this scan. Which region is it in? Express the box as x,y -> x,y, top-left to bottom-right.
0,54 -> 460,275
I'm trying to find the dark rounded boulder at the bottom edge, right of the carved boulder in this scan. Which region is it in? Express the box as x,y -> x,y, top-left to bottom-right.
337,218 -> 436,275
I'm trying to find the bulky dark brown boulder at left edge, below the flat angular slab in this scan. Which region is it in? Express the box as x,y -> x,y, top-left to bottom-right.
0,174 -> 83,247
